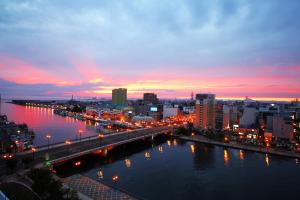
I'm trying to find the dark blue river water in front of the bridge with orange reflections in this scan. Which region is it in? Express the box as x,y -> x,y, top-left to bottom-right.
56,140 -> 300,200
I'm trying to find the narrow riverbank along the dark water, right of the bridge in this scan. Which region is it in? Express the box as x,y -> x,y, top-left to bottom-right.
179,135 -> 300,159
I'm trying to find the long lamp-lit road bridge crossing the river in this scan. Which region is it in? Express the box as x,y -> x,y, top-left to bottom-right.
11,126 -> 174,169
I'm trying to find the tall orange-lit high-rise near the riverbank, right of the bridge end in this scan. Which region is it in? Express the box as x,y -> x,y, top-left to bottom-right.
194,94 -> 216,129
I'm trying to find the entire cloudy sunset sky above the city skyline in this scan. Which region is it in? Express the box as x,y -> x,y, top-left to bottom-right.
0,0 -> 300,99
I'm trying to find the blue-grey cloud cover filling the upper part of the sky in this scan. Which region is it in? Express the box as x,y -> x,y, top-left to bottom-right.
0,0 -> 300,68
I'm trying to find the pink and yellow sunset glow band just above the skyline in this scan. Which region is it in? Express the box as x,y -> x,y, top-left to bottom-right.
0,55 -> 300,98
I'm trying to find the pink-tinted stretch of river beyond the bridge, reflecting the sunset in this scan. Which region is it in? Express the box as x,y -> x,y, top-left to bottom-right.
1,101 -> 96,146
